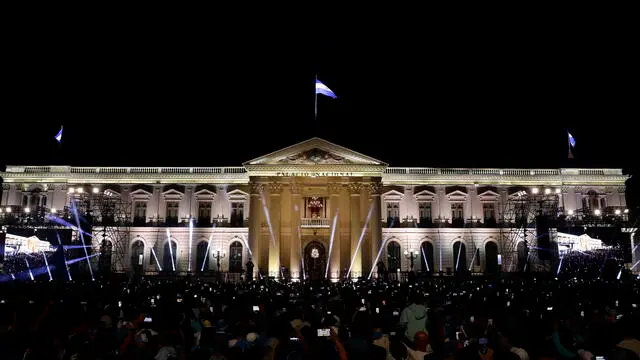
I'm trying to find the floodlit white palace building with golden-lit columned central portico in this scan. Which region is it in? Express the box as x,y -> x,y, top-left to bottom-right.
0,138 -> 628,280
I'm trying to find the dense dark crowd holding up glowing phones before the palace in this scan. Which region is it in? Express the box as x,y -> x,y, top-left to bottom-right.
0,253 -> 640,360
